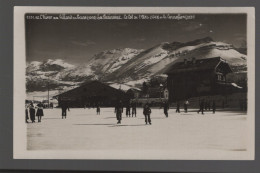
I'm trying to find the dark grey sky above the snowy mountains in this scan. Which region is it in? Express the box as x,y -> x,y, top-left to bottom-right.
26,14 -> 246,64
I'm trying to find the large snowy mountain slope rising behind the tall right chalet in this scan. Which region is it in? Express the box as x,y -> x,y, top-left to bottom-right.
103,37 -> 247,82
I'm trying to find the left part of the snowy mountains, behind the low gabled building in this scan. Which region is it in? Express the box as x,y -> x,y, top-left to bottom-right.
26,48 -> 142,91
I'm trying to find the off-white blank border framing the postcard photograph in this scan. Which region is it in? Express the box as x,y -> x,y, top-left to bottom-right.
13,6 -> 255,160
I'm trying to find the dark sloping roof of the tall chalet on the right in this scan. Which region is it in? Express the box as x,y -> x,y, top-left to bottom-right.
165,57 -> 232,74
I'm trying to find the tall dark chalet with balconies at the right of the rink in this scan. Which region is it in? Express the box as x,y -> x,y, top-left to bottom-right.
165,57 -> 242,102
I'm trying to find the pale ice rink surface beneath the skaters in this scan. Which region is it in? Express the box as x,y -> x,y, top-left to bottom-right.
27,108 -> 247,157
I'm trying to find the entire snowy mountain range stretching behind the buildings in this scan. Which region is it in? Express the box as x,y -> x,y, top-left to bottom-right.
26,37 -> 247,92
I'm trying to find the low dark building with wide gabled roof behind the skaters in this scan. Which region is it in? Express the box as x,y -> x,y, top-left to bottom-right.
55,81 -> 129,107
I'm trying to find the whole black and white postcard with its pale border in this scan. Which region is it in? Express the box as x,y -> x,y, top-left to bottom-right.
13,7 -> 255,160
